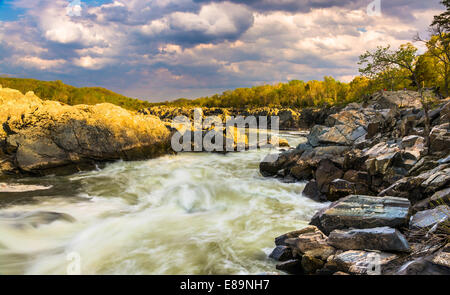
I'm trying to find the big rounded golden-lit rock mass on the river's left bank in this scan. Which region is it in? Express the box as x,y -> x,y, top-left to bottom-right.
0,89 -> 171,174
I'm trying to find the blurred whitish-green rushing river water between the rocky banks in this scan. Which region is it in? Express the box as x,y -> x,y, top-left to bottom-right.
0,134 -> 324,274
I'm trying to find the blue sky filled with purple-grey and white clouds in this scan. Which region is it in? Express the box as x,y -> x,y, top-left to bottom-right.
0,0 -> 443,101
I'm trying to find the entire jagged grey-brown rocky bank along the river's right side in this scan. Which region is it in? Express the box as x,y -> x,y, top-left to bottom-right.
260,92 -> 450,274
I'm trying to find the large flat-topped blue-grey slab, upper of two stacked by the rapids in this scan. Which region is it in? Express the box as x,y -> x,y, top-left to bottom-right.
310,195 -> 411,234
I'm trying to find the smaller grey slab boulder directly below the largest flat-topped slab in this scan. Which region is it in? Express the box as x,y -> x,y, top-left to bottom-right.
328,227 -> 409,251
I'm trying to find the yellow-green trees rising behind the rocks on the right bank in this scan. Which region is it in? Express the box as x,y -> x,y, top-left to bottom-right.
160,0 -> 450,108
